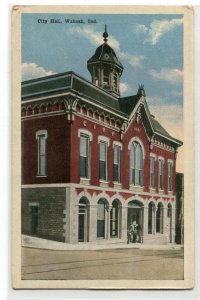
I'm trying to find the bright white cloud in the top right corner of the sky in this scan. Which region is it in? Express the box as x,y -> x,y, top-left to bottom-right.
135,19 -> 183,45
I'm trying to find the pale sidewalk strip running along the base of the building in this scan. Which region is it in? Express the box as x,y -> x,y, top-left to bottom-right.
22,235 -> 183,251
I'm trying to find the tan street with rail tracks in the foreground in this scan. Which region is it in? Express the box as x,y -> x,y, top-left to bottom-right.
22,247 -> 184,280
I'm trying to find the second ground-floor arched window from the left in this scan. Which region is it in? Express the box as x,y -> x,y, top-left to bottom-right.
97,199 -> 106,239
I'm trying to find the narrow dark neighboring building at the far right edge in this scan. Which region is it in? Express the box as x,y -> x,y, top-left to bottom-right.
175,173 -> 184,244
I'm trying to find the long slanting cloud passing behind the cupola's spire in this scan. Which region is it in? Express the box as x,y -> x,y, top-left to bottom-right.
67,27 -> 144,68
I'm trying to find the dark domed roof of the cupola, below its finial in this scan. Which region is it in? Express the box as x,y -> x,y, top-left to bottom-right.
87,42 -> 123,69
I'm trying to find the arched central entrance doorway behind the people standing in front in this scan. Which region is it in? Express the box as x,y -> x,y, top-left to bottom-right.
127,200 -> 144,242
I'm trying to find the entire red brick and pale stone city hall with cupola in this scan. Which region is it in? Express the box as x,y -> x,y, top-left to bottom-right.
21,31 -> 182,244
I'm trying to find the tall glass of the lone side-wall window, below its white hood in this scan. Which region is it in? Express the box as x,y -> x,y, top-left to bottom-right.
38,134 -> 46,176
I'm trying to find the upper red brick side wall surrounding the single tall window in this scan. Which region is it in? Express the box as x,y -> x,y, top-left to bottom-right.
22,115 -> 70,184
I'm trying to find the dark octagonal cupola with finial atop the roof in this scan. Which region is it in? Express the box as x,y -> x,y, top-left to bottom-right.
87,25 -> 123,96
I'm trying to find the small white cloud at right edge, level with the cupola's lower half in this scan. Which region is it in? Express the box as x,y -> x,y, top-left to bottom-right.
149,68 -> 183,84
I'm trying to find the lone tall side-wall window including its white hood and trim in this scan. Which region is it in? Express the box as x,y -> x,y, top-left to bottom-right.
36,130 -> 47,176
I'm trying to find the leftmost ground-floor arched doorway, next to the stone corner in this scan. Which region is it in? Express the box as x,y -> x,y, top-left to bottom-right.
78,197 -> 89,242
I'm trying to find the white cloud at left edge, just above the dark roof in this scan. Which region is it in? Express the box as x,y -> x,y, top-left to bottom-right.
21,62 -> 55,81
